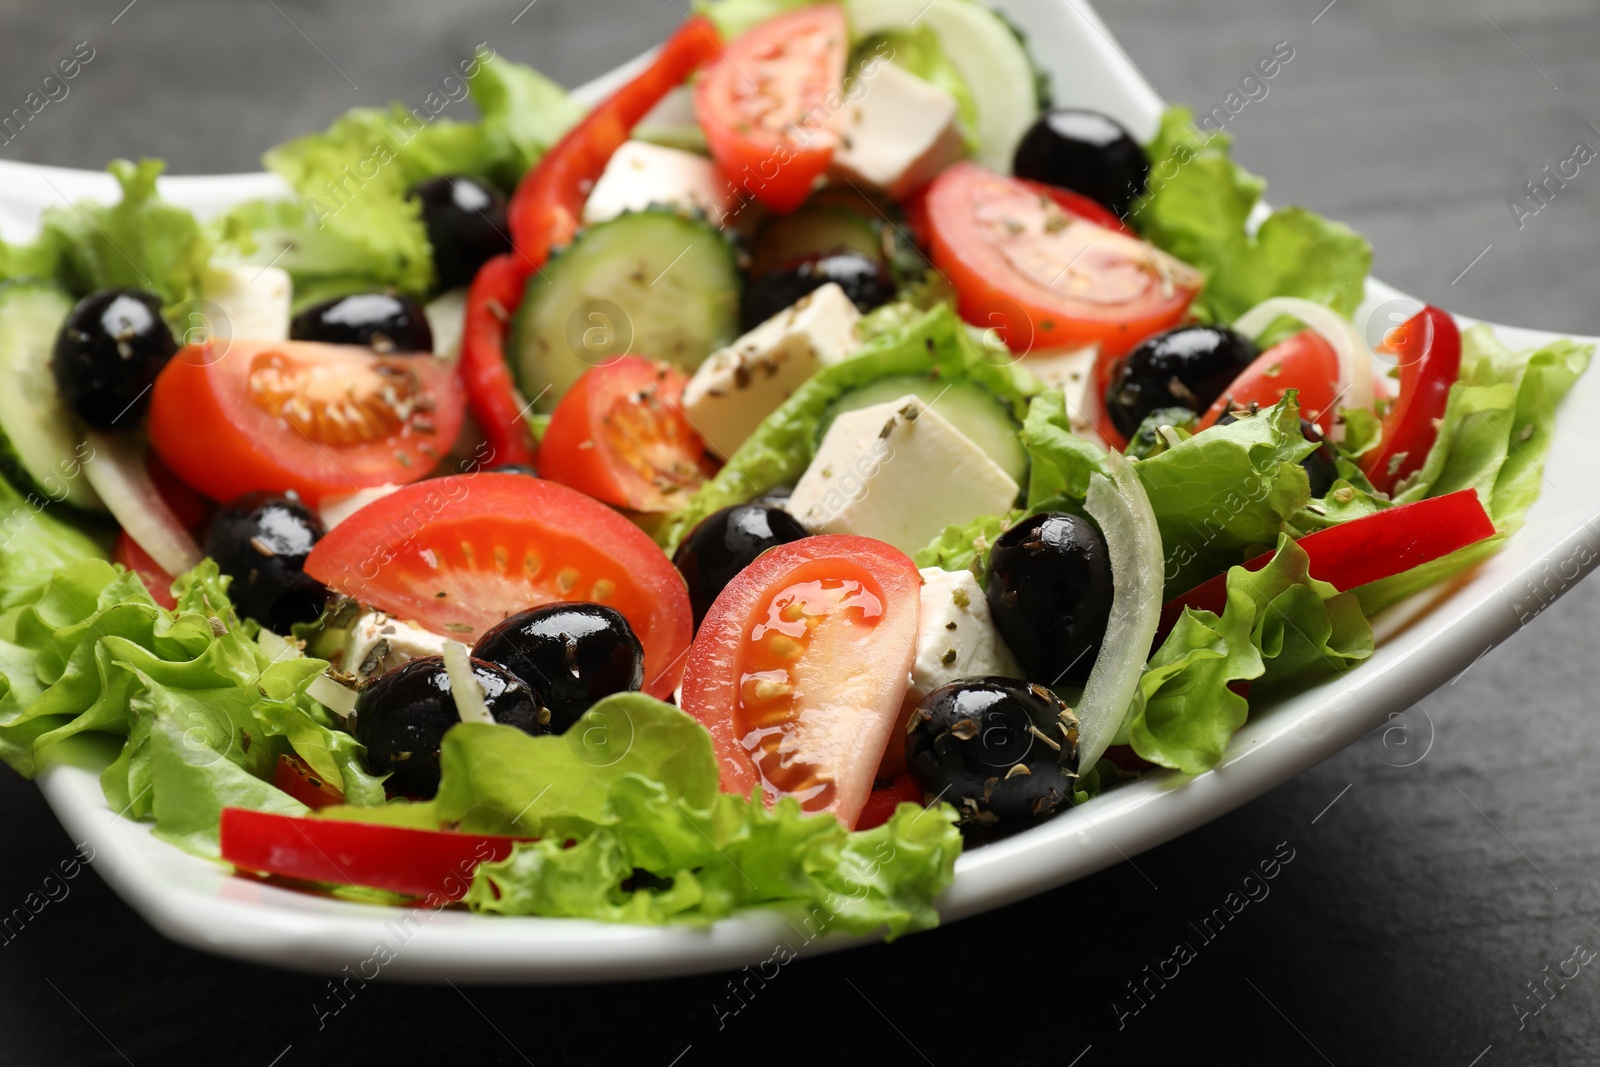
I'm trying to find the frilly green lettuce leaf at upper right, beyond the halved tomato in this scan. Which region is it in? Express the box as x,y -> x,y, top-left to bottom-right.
1130,107 -> 1373,322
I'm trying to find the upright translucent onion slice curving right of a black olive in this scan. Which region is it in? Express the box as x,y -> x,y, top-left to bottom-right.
1077,453 -> 1166,774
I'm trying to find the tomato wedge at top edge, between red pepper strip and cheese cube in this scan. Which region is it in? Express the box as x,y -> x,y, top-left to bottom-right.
694,3 -> 850,211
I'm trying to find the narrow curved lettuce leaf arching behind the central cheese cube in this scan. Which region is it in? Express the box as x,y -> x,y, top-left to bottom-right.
656,304 -> 1040,553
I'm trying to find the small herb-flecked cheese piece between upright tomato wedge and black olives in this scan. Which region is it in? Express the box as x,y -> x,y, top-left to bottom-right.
906,566 -> 1022,704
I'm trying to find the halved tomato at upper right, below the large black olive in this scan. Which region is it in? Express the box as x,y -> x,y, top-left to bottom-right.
926,163 -> 1202,357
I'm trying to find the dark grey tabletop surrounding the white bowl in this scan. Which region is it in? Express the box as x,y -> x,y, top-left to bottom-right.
0,0 -> 1600,1067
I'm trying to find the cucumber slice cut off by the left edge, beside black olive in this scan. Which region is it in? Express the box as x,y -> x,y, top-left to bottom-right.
0,280 -> 106,512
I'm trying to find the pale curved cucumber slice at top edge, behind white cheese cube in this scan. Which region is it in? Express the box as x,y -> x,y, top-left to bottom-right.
845,0 -> 1038,174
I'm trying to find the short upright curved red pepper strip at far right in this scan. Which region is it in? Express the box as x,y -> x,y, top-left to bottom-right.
1362,304 -> 1461,493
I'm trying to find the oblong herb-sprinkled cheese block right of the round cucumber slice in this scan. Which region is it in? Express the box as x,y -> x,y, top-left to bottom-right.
683,282 -> 861,459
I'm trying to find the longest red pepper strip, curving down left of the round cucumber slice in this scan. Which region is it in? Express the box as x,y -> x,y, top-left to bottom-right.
461,16 -> 722,464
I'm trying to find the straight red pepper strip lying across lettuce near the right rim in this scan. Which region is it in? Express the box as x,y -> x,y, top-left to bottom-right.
1160,490 -> 1494,633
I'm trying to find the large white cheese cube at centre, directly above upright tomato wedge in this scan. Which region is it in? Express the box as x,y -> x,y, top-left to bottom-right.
789,394 -> 1019,555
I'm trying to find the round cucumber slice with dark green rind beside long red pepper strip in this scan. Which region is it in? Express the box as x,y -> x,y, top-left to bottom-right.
510,208 -> 739,411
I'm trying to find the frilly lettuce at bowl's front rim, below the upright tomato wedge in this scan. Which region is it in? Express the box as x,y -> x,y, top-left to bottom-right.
322,693 -> 962,937
